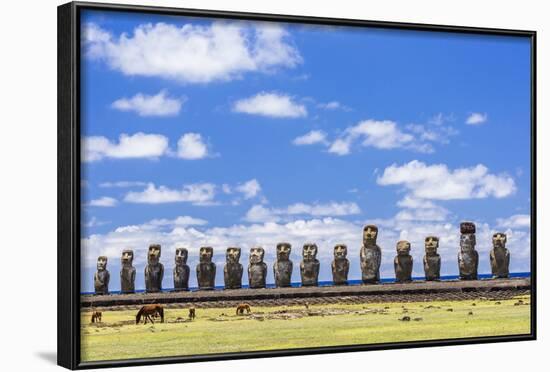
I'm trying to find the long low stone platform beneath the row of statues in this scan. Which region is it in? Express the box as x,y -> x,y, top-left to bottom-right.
80,278 -> 531,308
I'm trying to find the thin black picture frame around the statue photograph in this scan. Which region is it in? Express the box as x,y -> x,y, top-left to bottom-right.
57,2 -> 537,369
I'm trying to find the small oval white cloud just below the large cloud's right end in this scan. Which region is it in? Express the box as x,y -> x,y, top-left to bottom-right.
233,92 -> 307,118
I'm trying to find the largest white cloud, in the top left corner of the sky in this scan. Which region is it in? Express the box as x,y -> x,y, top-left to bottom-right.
83,22 -> 302,83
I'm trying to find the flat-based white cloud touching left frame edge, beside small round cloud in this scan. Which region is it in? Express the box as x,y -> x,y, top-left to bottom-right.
82,132 -> 168,162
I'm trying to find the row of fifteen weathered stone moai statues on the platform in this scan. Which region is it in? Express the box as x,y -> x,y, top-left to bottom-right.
94,222 -> 510,294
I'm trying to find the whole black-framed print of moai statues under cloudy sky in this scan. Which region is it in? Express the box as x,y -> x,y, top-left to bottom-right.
58,3 -> 536,369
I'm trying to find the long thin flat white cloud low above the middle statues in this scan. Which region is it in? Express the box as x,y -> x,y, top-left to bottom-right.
244,202 -> 361,222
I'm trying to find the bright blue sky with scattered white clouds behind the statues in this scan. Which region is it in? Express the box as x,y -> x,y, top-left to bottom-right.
81,11 -> 530,291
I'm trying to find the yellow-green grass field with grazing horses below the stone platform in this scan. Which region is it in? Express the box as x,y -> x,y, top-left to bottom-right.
81,296 -> 530,362
